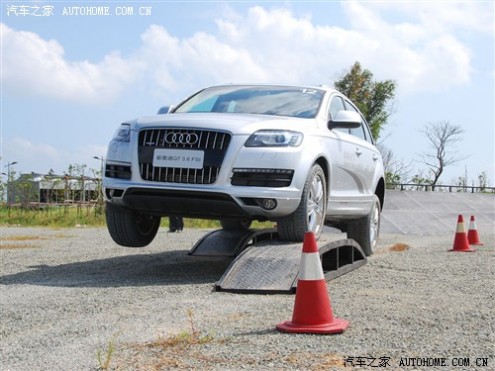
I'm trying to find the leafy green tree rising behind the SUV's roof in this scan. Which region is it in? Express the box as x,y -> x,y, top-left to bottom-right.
334,62 -> 396,139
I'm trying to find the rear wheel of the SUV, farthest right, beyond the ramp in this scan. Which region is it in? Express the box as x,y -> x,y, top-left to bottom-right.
347,195 -> 381,256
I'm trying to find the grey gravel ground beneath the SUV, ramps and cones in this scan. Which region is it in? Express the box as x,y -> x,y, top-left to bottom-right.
0,227 -> 495,371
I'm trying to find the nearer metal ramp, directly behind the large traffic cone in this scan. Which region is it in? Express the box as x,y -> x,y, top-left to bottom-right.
216,235 -> 366,294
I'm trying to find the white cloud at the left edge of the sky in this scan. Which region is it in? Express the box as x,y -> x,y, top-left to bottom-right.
0,24 -> 138,102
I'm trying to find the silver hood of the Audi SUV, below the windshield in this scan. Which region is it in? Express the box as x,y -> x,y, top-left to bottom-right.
129,113 -> 316,135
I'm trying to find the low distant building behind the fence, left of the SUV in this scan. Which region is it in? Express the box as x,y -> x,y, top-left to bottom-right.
7,173 -> 101,204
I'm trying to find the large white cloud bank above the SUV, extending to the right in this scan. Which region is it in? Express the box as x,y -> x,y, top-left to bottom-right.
135,2 -> 484,93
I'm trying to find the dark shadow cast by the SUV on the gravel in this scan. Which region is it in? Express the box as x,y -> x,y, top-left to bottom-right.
0,250 -> 231,288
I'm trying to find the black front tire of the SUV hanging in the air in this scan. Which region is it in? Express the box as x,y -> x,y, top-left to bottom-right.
106,202 -> 160,247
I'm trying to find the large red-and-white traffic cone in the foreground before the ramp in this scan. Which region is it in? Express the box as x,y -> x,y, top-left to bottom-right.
276,232 -> 349,334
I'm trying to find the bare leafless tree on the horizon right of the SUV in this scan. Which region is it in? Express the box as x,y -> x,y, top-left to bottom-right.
422,121 -> 465,186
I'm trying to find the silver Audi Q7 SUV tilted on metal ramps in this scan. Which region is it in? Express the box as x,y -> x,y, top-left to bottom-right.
104,85 -> 385,255
